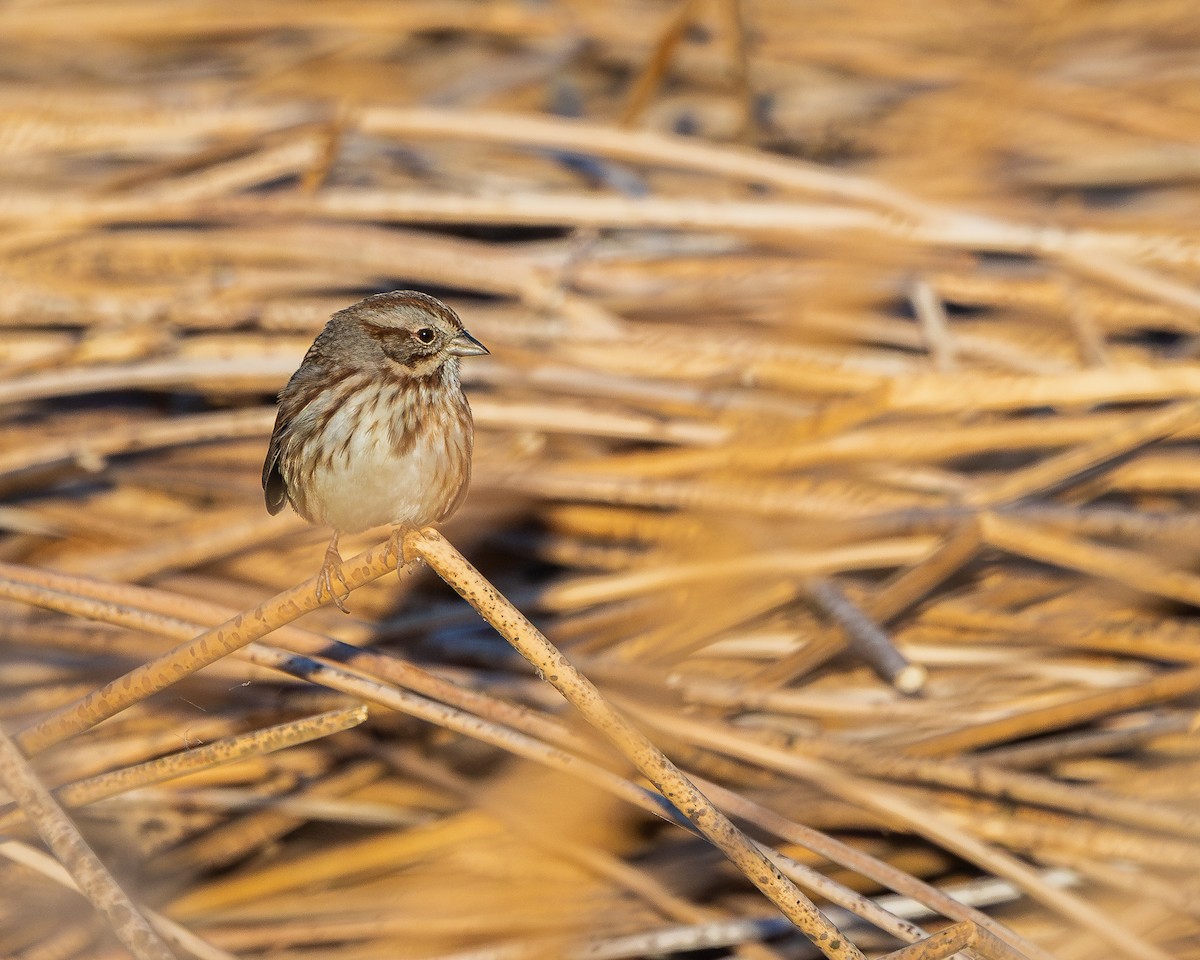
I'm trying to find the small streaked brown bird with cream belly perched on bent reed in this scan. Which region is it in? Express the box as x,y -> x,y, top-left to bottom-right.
263,290 -> 487,610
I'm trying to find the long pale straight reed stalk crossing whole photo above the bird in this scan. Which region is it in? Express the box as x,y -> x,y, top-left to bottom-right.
9,177 -> 1200,310
